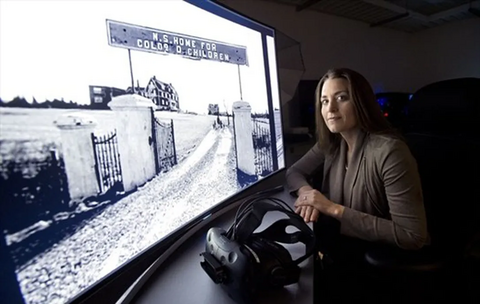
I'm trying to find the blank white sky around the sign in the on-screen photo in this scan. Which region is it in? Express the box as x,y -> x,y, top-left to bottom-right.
0,0 -> 278,113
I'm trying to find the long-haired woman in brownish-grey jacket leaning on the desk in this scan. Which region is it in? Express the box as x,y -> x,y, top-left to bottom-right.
286,69 -> 428,255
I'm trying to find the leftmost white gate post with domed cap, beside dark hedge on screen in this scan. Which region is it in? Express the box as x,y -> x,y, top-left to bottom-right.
54,113 -> 99,200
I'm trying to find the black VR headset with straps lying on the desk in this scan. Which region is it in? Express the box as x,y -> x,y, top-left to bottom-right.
200,198 -> 315,303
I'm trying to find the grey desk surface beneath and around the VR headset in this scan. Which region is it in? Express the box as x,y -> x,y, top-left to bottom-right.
132,186 -> 314,304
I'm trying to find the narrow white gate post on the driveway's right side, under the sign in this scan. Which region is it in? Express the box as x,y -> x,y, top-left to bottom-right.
232,101 -> 257,186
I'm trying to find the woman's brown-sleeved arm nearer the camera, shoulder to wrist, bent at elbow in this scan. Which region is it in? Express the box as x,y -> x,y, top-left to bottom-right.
336,141 -> 428,249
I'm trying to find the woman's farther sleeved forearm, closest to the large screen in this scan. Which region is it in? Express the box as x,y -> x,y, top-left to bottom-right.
285,144 -> 325,196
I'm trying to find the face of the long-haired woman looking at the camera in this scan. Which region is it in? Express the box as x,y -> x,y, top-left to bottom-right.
320,78 -> 357,133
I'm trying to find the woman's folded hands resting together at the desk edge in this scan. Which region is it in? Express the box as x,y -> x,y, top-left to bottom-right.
294,189 -> 344,220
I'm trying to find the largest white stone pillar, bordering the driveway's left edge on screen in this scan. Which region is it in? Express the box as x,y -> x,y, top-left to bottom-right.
108,94 -> 156,191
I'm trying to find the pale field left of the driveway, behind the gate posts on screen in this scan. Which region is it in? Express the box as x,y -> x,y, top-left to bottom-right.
0,108 -> 214,161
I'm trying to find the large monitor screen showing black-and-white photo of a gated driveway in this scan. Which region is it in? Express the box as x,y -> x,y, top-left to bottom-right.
0,0 -> 285,303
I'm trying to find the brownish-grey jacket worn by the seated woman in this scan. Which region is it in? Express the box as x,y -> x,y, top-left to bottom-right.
286,133 -> 430,249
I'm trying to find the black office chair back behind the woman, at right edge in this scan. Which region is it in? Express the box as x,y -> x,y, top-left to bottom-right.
405,78 -> 480,249
